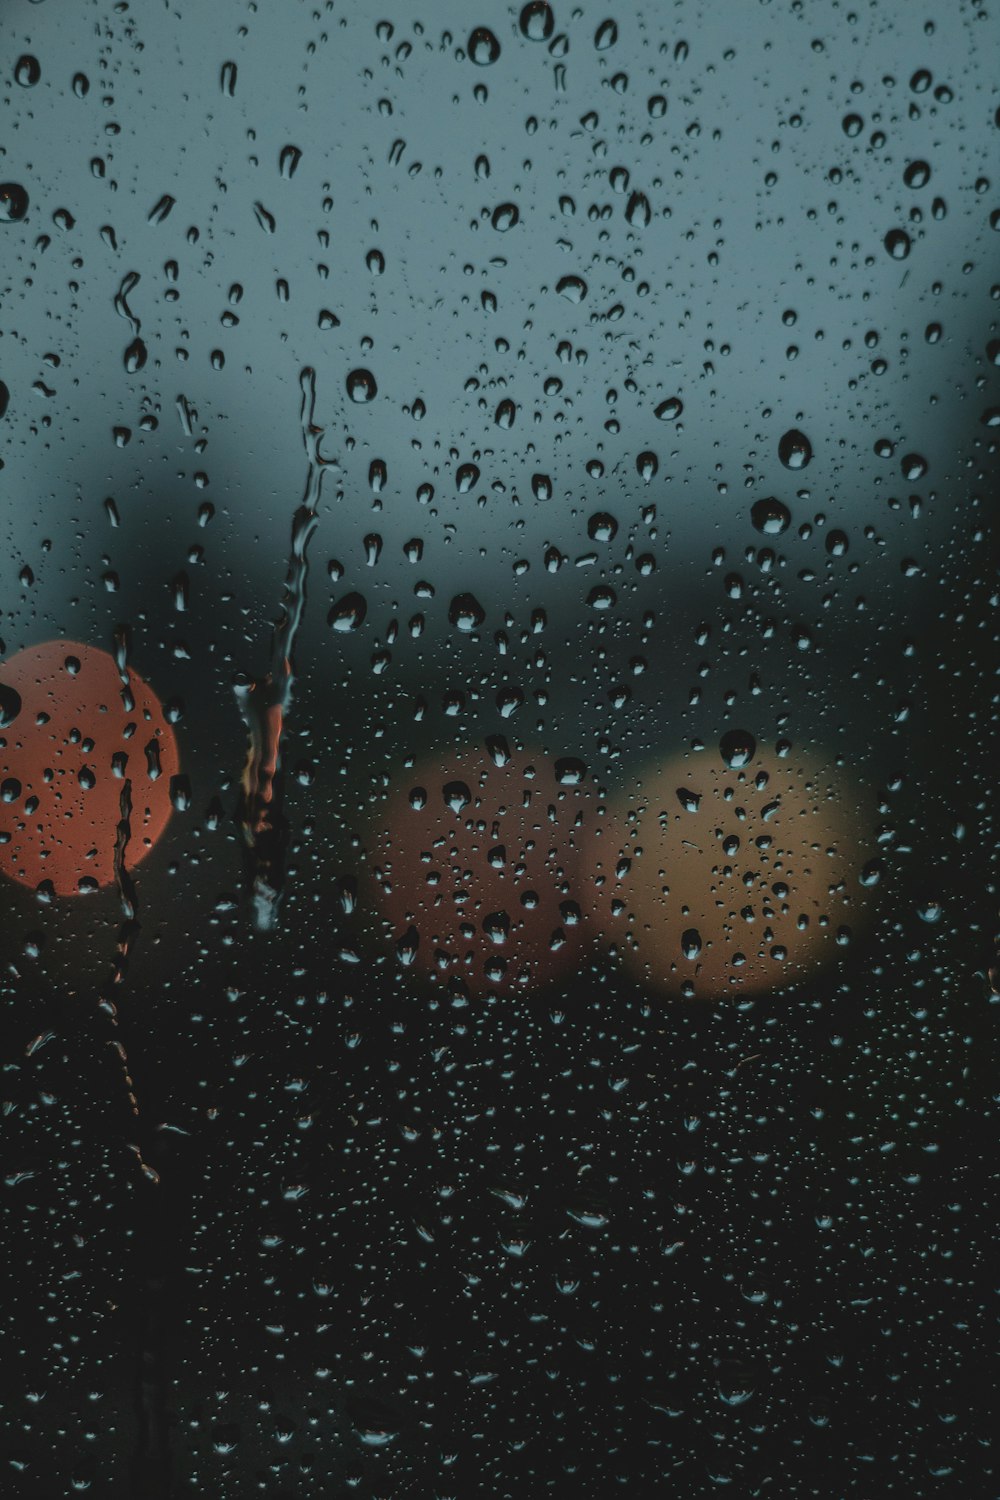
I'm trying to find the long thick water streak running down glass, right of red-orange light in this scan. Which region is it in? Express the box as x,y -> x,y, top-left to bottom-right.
234,368 -> 336,932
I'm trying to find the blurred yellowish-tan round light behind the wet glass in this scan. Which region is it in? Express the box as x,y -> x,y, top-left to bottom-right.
585,747 -> 874,1001
